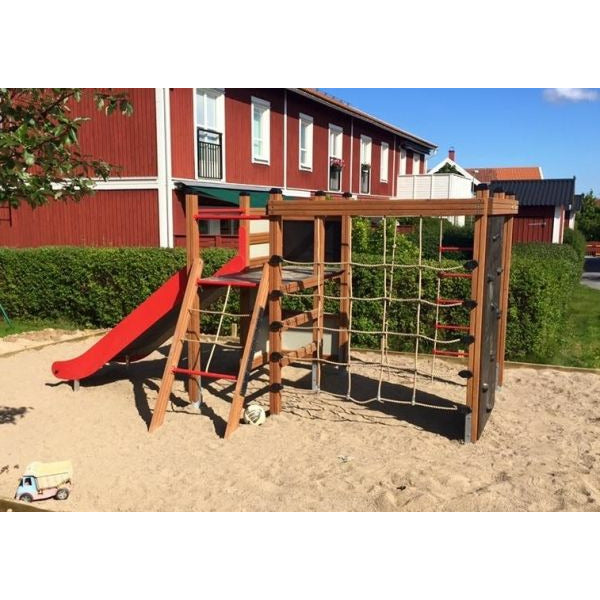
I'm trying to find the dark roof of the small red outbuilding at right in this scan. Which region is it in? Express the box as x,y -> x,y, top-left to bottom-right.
490,178 -> 575,208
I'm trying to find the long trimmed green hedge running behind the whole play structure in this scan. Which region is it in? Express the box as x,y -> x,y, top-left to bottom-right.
0,240 -> 582,360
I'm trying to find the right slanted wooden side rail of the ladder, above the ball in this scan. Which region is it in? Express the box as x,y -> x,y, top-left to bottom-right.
225,264 -> 270,439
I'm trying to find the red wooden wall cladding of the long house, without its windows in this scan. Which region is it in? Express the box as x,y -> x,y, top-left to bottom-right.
0,88 -> 434,247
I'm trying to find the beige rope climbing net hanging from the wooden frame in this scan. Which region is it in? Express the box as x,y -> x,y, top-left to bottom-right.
280,217 -> 474,410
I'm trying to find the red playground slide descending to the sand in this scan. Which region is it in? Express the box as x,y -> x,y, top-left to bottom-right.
52,268 -> 221,380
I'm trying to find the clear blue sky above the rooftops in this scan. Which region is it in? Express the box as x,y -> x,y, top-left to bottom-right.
320,88 -> 600,195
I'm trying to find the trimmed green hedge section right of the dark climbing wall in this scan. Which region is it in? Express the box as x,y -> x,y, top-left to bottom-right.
506,243 -> 581,362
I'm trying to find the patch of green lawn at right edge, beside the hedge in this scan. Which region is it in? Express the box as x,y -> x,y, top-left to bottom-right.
540,285 -> 600,369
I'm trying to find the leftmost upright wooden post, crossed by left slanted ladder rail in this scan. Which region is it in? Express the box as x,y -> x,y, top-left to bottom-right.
185,194 -> 201,404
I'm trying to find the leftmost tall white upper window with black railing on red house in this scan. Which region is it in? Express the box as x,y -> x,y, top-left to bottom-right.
196,88 -> 225,179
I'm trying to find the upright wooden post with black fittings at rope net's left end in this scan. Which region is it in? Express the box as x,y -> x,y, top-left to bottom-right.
269,189 -> 283,415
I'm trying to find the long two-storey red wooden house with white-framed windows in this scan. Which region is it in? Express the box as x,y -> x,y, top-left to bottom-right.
0,88 -> 436,247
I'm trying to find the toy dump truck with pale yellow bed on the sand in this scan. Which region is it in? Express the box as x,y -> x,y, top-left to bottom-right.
15,460 -> 73,502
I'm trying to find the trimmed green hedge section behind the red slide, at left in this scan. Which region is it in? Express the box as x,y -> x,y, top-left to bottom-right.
0,247 -> 232,327
